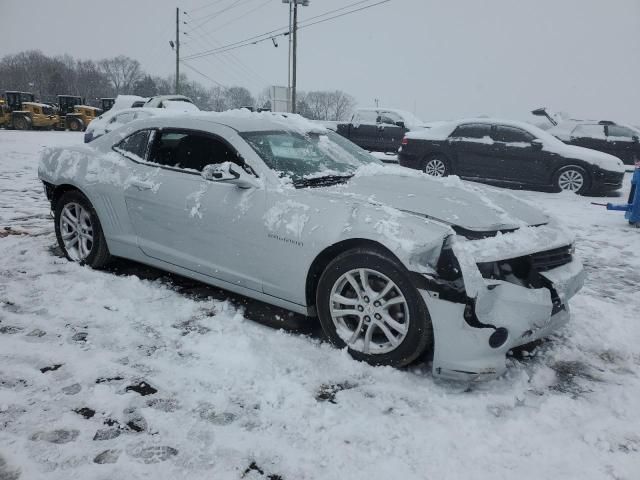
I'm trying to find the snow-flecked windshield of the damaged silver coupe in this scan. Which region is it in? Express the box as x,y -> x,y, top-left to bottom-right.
241,127 -> 381,183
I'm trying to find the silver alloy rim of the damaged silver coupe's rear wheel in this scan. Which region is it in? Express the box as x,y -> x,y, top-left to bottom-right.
60,203 -> 93,262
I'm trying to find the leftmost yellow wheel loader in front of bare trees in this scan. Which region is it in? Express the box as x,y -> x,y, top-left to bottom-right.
0,91 -> 58,130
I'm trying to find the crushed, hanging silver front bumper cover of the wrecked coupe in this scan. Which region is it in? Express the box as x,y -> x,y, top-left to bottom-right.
419,257 -> 585,381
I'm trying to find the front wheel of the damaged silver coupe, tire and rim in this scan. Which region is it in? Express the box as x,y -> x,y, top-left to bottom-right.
316,248 -> 433,367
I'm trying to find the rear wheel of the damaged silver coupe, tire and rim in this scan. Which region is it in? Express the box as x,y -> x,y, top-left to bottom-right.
53,190 -> 111,269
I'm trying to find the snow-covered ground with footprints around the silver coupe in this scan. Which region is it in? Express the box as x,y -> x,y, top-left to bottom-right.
0,131 -> 640,480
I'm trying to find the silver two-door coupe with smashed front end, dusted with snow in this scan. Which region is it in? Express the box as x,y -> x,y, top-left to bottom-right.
39,111 -> 584,379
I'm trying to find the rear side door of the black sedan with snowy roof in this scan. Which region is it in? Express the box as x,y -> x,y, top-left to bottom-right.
447,123 -> 499,178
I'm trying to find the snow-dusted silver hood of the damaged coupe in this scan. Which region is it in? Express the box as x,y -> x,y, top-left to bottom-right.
324,167 -> 549,234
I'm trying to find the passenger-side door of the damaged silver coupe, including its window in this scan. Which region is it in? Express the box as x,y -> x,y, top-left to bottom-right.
118,127 -> 265,291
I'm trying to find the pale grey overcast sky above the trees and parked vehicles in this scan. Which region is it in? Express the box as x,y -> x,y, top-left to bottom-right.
0,0 -> 640,124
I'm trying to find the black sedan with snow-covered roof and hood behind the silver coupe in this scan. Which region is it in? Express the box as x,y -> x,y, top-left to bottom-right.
398,118 -> 625,194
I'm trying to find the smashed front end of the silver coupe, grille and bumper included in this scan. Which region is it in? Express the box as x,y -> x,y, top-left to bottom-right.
413,225 -> 585,380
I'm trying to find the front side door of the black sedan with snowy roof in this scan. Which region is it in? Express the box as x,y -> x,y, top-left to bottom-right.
492,125 -> 551,185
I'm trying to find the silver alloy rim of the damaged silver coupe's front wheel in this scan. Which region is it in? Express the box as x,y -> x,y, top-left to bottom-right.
330,268 -> 410,355
